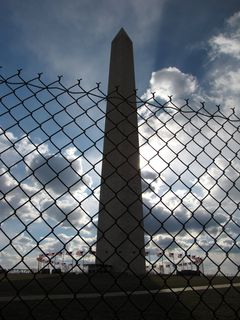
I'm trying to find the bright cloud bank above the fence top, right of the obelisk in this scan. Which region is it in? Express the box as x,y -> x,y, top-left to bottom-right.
142,12 -> 240,113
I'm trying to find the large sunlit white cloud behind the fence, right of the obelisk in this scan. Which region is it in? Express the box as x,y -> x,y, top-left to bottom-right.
139,77 -> 239,272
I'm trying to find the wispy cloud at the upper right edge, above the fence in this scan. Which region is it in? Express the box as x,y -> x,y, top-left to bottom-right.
206,12 -> 240,112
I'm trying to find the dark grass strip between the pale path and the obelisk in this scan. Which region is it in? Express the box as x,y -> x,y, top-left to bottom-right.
0,273 -> 240,296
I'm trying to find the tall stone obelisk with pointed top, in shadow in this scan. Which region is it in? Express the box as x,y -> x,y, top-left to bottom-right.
96,29 -> 145,274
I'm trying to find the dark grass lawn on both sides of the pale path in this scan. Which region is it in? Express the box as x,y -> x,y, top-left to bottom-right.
0,274 -> 240,320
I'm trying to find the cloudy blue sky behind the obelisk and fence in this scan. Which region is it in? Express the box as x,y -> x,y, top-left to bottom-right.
0,0 -> 240,273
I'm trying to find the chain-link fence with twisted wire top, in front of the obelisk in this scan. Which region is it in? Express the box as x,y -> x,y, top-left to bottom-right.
0,71 -> 240,319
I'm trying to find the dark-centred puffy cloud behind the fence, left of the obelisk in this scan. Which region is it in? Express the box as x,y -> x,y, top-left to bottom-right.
0,127 -> 96,228
